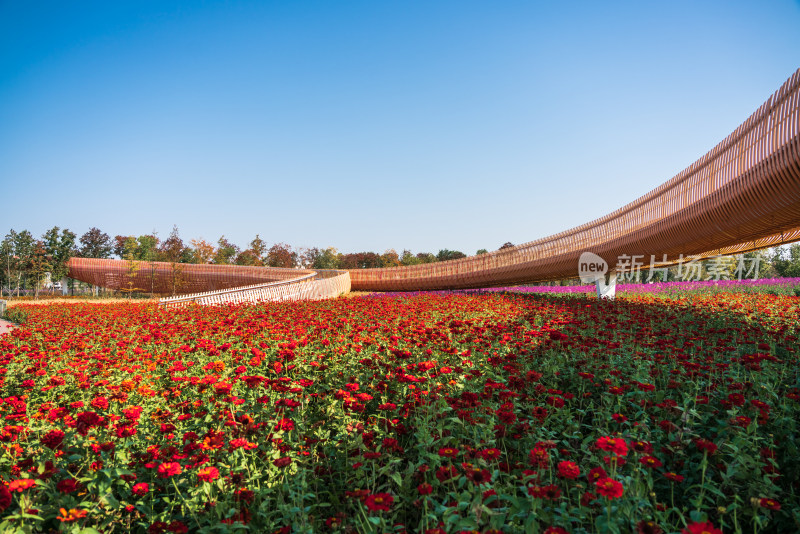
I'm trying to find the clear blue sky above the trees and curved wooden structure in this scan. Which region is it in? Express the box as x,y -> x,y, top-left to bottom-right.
0,0 -> 800,254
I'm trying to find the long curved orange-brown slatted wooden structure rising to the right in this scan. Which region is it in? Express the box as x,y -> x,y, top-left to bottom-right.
68,70 -> 800,302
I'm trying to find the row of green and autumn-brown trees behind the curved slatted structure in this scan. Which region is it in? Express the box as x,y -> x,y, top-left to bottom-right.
0,226 -> 800,294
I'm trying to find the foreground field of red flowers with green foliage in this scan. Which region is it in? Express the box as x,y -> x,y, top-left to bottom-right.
0,293 -> 800,534
